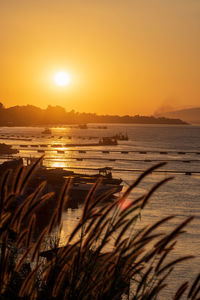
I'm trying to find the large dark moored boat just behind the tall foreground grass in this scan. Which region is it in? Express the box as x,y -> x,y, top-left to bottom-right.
27,158 -> 123,203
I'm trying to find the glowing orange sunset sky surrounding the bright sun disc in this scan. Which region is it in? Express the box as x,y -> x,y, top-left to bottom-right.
0,0 -> 200,115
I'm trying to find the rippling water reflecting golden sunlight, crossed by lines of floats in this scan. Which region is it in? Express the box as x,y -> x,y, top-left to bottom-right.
0,124 -> 200,299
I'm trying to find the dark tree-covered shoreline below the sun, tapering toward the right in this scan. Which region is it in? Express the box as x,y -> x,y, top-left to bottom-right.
0,103 -> 187,126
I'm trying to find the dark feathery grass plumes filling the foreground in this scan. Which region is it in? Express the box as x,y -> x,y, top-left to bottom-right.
0,158 -> 200,300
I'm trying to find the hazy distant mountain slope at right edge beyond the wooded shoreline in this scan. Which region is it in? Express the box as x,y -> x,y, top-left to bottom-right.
155,107 -> 200,124
